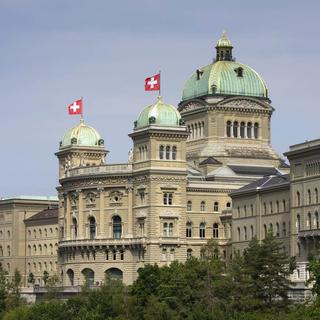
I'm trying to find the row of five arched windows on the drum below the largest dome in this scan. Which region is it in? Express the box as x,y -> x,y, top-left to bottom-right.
226,121 -> 259,139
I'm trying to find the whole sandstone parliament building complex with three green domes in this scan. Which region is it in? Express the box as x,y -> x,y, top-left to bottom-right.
0,34 -> 320,287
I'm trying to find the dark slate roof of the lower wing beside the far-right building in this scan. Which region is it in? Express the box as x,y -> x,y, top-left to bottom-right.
231,173 -> 290,196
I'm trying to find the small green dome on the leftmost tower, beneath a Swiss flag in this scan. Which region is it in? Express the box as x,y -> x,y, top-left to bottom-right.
60,119 -> 104,149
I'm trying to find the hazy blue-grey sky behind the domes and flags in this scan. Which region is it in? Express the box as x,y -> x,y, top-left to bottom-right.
0,0 -> 320,196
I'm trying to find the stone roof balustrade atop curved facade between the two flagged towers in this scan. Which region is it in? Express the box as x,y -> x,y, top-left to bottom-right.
65,163 -> 132,178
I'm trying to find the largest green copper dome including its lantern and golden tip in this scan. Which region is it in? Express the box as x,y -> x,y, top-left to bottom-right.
182,33 -> 268,100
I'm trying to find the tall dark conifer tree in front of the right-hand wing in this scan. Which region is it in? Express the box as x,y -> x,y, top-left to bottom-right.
244,233 -> 295,308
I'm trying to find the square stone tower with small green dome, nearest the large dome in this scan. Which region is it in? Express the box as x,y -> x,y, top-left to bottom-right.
130,97 -> 188,264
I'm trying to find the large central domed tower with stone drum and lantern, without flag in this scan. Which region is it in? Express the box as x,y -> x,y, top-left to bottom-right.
178,33 -> 283,171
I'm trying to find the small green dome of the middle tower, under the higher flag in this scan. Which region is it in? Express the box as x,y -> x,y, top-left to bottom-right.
134,96 -> 182,129
